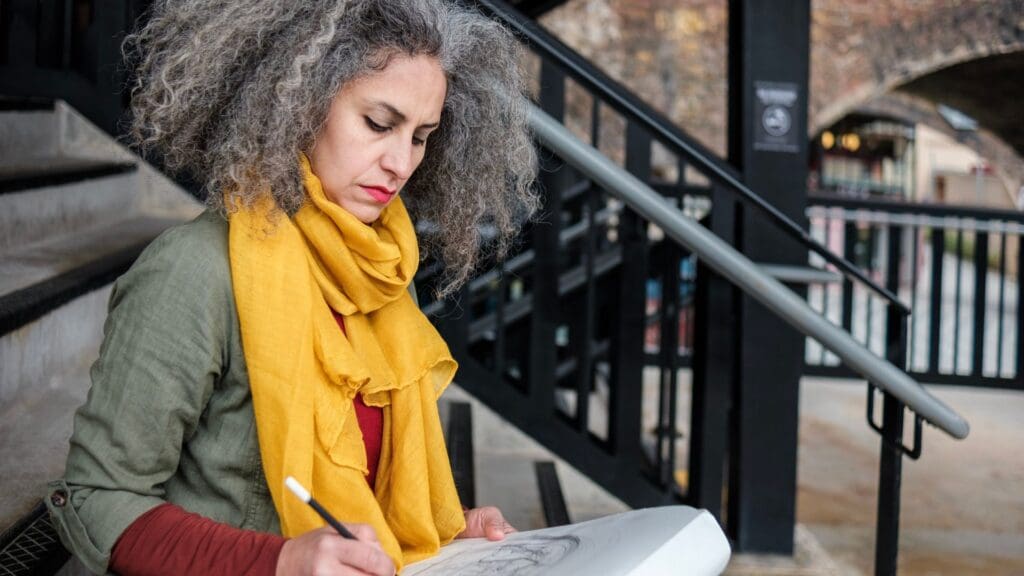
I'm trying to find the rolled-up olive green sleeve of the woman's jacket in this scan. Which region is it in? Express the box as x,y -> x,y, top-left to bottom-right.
44,217 -> 233,573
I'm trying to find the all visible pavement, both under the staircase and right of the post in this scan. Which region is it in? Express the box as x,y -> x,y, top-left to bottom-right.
445,371 -> 1024,576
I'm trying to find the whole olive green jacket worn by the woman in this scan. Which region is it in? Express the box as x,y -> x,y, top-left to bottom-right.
45,212 -> 281,573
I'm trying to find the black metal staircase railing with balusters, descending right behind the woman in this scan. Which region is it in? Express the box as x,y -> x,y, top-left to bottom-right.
435,0 -> 970,574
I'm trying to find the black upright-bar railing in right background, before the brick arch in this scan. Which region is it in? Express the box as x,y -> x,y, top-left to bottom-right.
806,196 -> 1024,389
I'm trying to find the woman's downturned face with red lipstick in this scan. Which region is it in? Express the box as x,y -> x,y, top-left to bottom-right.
309,55 -> 447,223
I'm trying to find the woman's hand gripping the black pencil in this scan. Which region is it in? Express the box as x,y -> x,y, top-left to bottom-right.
276,524 -> 394,576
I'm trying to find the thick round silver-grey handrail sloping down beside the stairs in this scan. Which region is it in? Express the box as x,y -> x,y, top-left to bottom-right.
529,107 -> 971,439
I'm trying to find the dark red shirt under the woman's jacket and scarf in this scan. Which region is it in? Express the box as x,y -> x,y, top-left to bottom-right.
110,314 -> 384,576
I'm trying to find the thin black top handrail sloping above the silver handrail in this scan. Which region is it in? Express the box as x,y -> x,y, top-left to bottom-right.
474,0 -> 910,316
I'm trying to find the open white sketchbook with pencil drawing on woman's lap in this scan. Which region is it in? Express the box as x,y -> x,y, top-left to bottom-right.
401,506 -> 729,576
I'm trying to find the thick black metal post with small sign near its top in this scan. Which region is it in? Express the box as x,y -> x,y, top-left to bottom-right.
727,0 -> 810,554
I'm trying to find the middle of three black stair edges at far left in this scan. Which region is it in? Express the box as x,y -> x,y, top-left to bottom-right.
0,156 -> 138,194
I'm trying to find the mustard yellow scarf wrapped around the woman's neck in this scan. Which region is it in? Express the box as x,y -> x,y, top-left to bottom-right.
229,156 -> 465,569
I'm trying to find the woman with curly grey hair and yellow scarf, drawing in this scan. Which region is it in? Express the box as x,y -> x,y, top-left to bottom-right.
47,0 -> 537,574
